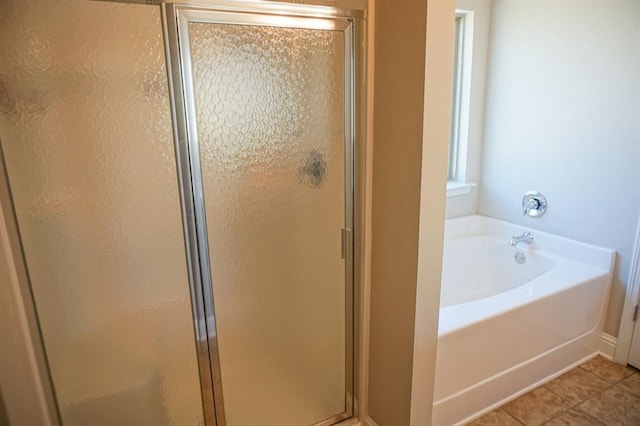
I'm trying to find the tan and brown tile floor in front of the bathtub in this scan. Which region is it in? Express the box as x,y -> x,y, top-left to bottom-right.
469,356 -> 640,426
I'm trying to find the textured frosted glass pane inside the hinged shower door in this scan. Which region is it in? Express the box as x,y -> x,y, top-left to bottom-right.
189,22 -> 346,426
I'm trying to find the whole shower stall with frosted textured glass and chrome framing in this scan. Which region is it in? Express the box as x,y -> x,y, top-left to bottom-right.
0,0 -> 366,426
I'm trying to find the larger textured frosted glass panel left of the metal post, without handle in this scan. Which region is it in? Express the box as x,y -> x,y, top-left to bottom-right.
0,0 -> 203,426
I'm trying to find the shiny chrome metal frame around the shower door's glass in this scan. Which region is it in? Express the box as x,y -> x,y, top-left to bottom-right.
162,1 -> 364,426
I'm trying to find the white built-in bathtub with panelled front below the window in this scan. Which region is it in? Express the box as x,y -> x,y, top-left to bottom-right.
433,216 -> 615,426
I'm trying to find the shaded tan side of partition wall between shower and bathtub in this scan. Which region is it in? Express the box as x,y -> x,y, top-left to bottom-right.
368,0 -> 453,426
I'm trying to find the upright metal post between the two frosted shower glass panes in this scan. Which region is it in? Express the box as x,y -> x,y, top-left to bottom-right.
161,3 -> 225,426
